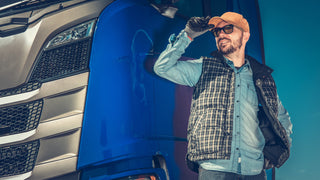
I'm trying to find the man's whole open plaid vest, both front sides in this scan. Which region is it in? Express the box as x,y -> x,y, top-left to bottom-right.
187,52 -> 289,172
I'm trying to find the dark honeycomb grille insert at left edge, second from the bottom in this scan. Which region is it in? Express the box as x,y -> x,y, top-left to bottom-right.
0,100 -> 43,136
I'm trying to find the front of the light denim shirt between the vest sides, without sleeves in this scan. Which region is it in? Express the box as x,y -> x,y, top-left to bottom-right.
199,59 -> 265,175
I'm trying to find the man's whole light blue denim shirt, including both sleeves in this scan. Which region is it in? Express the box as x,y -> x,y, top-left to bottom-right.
154,31 -> 292,175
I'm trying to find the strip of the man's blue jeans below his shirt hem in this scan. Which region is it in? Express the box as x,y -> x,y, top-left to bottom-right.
198,168 -> 267,180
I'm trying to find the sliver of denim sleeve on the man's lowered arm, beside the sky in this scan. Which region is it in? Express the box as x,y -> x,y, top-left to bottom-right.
278,96 -> 292,146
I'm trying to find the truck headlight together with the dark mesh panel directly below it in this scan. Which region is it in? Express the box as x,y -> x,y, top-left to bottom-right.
29,20 -> 96,82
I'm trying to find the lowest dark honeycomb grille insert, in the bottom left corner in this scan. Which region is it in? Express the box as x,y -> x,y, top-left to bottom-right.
0,140 -> 40,177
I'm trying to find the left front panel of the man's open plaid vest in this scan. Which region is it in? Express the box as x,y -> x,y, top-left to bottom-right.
188,53 -> 235,161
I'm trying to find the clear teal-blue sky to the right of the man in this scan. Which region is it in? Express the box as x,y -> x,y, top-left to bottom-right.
259,0 -> 320,180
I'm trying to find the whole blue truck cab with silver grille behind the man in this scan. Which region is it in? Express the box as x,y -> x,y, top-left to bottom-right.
0,0 -> 264,180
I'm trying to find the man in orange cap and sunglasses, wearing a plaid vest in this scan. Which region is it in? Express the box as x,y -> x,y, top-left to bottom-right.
154,12 -> 292,180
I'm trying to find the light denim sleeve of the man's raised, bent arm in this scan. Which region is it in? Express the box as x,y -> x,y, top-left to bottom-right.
153,31 -> 202,87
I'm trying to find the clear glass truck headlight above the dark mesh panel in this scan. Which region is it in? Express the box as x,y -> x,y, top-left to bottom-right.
46,20 -> 95,48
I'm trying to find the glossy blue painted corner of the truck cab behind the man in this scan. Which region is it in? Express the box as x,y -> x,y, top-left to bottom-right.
78,0 -> 268,179
